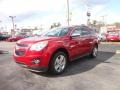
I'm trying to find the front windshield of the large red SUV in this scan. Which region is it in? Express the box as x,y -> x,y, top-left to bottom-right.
42,28 -> 68,37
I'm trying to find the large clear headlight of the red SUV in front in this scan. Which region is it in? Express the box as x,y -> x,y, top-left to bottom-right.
30,41 -> 48,51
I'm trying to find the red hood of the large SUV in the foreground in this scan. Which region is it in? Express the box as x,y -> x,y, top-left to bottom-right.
17,37 -> 57,44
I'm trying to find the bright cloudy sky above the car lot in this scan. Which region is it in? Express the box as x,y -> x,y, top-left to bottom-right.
0,0 -> 120,28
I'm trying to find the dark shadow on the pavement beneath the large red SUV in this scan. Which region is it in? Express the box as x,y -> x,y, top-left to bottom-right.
32,51 -> 115,78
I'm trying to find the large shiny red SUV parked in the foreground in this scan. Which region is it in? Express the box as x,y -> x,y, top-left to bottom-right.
14,26 -> 98,74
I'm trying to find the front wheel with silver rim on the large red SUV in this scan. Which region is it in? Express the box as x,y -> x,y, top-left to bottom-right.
49,52 -> 67,74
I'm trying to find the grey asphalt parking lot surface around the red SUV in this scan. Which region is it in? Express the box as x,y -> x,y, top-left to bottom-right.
0,42 -> 120,90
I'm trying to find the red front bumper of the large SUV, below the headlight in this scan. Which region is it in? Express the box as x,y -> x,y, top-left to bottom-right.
13,50 -> 50,72
